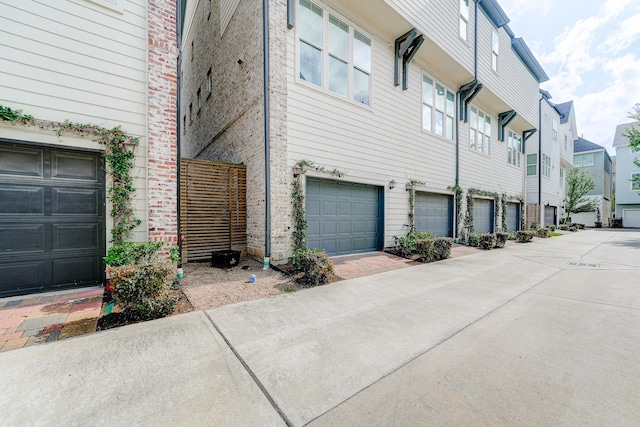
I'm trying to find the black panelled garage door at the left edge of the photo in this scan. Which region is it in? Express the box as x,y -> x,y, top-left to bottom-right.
0,141 -> 105,295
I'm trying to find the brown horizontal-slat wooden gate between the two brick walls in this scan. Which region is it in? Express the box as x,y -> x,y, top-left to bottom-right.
180,159 -> 247,263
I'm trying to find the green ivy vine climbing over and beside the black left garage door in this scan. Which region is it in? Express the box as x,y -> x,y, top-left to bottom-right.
0,105 -> 141,245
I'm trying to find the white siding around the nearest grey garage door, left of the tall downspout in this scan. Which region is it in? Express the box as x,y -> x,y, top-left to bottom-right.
287,1 -> 456,246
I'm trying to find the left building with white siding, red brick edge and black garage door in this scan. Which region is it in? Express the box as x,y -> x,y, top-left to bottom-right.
0,0 -> 178,297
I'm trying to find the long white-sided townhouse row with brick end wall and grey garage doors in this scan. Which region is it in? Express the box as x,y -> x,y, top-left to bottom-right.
181,0 -> 547,262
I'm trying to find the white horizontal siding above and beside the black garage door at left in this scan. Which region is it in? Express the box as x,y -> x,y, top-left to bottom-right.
0,0 -> 147,240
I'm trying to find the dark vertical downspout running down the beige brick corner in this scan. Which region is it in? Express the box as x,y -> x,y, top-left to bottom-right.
262,0 -> 271,270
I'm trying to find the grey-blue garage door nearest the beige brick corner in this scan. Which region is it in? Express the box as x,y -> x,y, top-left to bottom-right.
306,178 -> 383,255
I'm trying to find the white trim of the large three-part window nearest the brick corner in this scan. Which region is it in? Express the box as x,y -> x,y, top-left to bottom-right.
295,0 -> 375,109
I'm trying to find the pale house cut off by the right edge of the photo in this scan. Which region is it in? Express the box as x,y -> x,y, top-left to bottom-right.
613,122 -> 640,227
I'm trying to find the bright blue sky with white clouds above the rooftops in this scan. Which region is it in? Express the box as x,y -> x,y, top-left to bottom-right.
499,0 -> 640,154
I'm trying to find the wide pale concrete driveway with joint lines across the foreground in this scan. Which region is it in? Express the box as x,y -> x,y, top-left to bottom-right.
0,230 -> 640,426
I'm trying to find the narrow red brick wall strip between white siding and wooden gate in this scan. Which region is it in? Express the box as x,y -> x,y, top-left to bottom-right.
147,0 -> 178,244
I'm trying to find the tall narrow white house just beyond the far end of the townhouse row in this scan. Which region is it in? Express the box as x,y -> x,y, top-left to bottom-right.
526,94 -> 576,227
